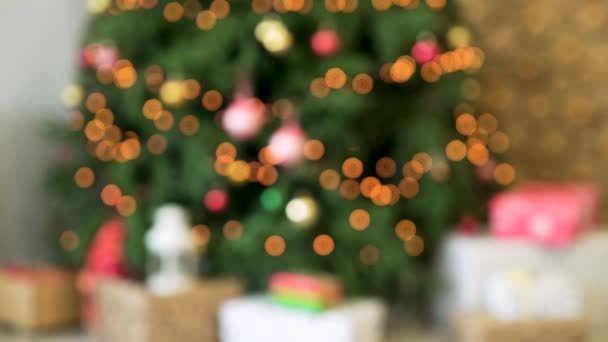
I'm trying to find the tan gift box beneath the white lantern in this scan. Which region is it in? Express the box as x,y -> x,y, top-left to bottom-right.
96,279 -> 244,342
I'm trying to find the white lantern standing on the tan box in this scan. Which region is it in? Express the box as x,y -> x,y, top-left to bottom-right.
145,204 -> 197,295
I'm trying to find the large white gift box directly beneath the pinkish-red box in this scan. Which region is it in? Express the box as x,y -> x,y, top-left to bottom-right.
436,228 -> 608,327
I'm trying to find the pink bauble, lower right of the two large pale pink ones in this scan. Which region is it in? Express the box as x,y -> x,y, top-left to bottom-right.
268,123 -> 306,166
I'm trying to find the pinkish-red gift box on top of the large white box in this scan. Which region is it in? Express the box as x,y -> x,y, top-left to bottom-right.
490,183 -> 600,247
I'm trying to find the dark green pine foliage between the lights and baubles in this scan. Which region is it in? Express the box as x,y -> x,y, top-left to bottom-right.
48,0 -> 492,298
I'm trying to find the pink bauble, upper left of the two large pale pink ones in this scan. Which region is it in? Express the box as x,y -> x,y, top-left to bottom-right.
222,97 -> 265,140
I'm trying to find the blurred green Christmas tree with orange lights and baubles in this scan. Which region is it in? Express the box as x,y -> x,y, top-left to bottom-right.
49,0 -> 504,298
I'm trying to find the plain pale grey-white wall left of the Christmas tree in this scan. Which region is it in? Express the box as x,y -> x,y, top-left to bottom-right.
0,0 -> 86,262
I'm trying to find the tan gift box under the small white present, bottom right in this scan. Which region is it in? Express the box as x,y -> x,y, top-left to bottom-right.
451,314 -> 588,342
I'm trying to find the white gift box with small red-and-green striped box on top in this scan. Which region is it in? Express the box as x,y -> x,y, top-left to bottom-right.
219,296 -> 387,342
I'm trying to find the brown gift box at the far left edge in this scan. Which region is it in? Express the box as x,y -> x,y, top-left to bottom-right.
0,266 -> 79,331
